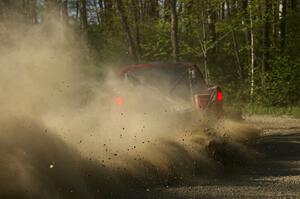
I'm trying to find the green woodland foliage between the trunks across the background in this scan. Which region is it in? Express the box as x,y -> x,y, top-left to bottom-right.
0,0 -> 300,112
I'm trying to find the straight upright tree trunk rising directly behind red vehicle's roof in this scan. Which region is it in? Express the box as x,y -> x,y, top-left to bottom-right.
170,0 -> 179,62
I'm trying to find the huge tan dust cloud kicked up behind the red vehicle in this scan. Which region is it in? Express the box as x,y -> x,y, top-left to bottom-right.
0,19 -> 259,198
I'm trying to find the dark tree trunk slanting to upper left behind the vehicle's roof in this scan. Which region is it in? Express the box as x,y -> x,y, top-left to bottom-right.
116,0 -> 138,62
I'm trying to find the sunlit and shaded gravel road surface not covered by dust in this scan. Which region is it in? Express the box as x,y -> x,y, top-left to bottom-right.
132,116 -> 300,199
